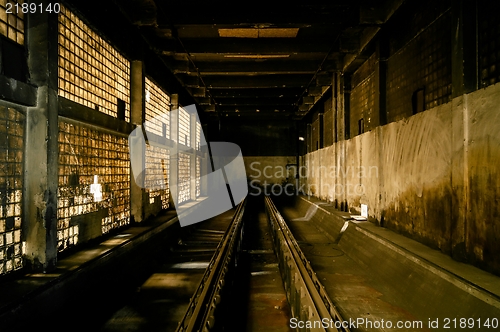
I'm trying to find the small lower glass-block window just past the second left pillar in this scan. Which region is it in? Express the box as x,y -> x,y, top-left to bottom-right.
145,145 -> 170,209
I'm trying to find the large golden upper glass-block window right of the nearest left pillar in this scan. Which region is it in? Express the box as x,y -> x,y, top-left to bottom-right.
59,6 -> 130,121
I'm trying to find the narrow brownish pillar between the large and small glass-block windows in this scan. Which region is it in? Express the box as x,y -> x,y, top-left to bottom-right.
130,61 -> 145,222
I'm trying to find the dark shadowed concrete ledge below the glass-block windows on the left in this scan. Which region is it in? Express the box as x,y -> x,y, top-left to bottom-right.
0,198 -> 209,331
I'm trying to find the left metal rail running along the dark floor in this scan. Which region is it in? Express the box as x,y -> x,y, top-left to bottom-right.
176,199 -> 246,332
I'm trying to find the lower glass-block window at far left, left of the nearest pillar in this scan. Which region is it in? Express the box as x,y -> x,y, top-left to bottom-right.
0,107 -> 25,275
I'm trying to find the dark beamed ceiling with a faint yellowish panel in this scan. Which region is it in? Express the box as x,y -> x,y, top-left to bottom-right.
65,0 -> 403,118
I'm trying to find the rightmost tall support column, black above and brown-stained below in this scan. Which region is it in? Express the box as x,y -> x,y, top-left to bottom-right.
450,0 -> 479,261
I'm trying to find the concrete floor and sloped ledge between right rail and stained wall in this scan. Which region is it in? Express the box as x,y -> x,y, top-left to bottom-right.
278,196 -> 500,331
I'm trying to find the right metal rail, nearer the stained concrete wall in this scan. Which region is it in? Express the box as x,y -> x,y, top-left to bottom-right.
265,196 -> 349,332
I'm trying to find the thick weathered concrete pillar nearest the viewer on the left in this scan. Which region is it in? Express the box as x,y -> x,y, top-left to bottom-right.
23,6 -> 59,272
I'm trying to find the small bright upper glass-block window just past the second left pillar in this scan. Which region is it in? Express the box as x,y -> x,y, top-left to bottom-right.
145,77 -> 170,138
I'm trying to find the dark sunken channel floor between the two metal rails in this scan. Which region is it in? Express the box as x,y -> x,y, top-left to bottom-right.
224,196 -> 293,332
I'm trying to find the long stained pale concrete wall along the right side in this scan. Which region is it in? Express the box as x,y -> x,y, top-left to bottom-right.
301,84 -> 500,274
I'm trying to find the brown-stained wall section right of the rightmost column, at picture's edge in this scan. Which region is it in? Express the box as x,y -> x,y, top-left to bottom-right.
464,84 -> 500,272
